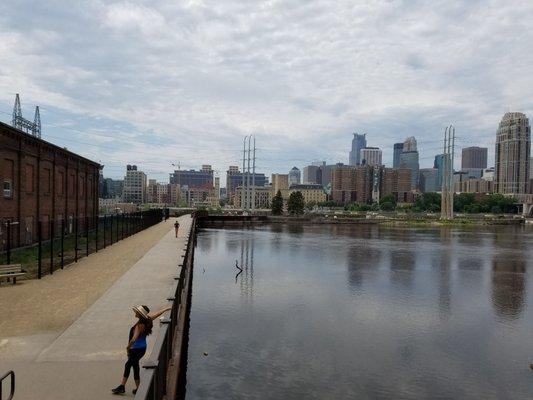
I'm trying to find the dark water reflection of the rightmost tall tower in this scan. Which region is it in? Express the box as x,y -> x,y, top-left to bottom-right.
491,259 -> 526,319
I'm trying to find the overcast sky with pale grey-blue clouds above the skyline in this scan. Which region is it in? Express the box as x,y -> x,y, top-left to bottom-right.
0,0 -> 533,182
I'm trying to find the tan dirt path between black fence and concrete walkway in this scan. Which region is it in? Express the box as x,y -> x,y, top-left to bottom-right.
0,218 -> 175,338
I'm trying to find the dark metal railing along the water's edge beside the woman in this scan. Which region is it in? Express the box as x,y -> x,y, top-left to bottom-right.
135,219 -> 196,400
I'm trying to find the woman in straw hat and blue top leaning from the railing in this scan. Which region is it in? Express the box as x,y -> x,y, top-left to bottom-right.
111,306 -> 172,394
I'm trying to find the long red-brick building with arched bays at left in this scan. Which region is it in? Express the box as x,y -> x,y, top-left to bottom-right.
0,122 -> 100,248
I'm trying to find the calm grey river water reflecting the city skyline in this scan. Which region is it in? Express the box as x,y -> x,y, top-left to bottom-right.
186,225 -> 533,400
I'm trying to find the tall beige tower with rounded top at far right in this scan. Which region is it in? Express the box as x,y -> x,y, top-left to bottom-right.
494,112 -> 531,194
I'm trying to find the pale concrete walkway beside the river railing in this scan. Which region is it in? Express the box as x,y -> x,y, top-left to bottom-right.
0,216 -> 192,400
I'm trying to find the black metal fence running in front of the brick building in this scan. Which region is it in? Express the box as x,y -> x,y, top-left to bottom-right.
0,209 -> 168,279
